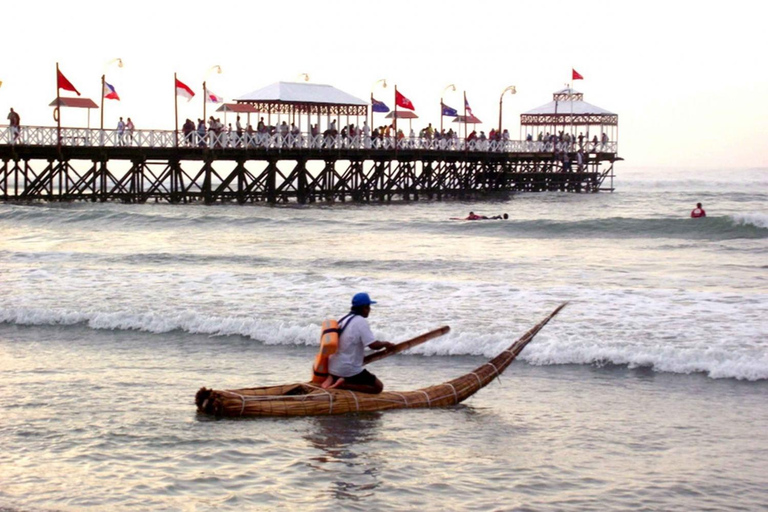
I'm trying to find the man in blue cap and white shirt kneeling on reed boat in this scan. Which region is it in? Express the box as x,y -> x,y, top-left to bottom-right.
323,292 -> 395,394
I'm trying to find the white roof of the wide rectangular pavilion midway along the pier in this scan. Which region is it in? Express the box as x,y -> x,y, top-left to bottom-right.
235,82 -> 368,115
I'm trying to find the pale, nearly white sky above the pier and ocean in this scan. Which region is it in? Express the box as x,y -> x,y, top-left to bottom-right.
0,0 -> 768,172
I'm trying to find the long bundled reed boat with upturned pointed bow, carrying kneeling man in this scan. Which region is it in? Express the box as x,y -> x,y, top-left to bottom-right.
195,303 -> 567,417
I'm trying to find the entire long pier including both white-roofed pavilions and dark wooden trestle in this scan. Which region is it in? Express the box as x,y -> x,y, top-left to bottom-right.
0,82 -> 621,204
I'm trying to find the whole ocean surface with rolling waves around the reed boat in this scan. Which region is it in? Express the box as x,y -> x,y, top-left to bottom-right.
0,164 -> 768,512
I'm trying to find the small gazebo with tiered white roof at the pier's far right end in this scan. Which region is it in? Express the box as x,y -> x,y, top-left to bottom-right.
520,88 -> 619,147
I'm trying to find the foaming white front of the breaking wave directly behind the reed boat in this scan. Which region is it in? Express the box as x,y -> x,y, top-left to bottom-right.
0,308 -> 768,381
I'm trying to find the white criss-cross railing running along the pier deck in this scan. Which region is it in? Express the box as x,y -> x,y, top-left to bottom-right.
0,126 -> 617,154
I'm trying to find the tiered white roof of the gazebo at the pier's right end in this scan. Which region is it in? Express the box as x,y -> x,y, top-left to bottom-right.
520,88 -> 619,125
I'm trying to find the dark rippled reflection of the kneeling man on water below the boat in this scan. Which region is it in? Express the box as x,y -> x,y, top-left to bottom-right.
304,412 -> 384,501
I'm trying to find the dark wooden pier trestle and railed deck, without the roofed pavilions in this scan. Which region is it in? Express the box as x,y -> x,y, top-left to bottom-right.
0,127 -> 621,204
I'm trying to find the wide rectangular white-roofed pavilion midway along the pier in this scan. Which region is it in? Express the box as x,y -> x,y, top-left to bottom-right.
235,82 -> 368,132
